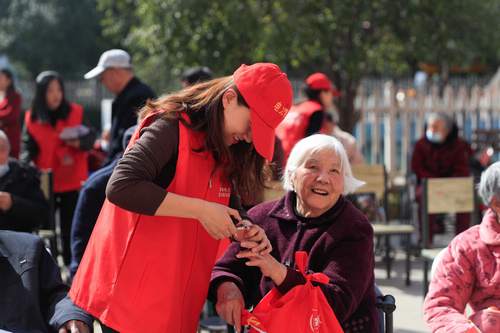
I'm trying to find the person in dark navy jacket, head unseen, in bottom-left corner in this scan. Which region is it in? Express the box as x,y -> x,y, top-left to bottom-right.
0,230 -> 93,333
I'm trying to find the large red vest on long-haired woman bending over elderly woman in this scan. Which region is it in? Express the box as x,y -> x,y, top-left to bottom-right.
69,116 -> 231,333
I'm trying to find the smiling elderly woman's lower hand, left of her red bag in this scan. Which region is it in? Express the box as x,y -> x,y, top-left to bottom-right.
215,282 -> 245,333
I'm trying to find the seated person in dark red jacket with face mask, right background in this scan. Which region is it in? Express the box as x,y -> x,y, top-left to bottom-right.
411,112 -> 472,244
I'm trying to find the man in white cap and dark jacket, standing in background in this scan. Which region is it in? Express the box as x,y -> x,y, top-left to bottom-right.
84,49 -> 155,167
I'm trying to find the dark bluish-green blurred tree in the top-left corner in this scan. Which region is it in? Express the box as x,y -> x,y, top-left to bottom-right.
0,0 -> 109,79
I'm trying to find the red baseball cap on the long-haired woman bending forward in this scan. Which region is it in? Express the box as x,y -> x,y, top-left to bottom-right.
233,63 -> 293,161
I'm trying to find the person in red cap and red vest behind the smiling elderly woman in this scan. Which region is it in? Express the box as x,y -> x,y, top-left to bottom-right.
276,73 -> 341,165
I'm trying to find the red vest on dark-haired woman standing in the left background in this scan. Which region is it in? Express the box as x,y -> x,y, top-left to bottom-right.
24,103 -> 89,193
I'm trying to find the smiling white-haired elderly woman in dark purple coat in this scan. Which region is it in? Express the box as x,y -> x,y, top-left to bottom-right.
209,134 -> 379,332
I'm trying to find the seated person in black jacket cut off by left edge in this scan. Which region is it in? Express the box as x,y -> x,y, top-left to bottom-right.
0,130 -> 49,232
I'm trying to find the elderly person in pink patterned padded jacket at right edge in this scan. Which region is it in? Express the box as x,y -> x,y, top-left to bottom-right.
424,162 -> 500,333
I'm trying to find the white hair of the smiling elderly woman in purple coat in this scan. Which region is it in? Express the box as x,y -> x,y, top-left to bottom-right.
283,134 -> 364,195
